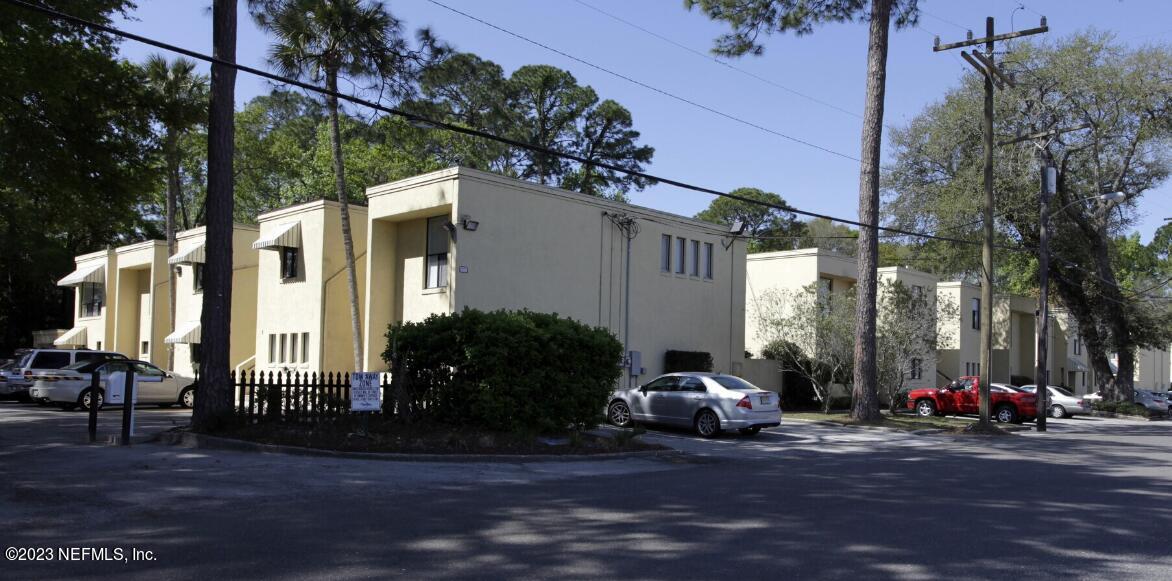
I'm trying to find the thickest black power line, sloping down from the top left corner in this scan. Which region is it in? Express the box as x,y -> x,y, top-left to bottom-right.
0,0 -> 998,251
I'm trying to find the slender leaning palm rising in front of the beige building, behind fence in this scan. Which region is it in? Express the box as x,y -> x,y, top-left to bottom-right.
250,0 -> 404,371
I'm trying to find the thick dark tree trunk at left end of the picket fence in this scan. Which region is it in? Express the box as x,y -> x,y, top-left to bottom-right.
192,0 -> 236,432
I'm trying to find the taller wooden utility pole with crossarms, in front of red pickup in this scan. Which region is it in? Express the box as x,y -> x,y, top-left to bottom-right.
932,16 -> 1050,429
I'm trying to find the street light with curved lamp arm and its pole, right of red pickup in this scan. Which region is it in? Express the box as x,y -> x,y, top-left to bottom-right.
1034,183 -> 1127,432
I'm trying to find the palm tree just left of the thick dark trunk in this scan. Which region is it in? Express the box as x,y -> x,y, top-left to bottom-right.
142,54 -> 207,369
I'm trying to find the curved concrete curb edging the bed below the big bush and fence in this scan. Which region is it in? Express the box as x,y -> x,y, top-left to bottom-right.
154,431 -> 684,464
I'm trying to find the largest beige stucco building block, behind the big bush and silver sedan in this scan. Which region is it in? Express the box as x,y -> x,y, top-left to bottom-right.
363,168 -> 744,382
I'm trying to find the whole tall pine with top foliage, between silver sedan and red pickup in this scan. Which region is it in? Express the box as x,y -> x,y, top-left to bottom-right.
684,0 -> 919,422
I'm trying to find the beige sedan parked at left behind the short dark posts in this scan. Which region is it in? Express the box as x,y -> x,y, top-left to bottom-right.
29,360 -> 196,410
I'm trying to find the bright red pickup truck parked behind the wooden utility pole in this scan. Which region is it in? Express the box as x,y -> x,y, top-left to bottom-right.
907,376 -> 1037,424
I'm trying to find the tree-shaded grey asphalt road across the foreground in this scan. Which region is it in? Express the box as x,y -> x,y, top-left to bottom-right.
0,403 -> 1172,580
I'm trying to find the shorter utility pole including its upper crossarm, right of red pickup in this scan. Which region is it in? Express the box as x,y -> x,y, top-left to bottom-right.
997,123 -> 1092,432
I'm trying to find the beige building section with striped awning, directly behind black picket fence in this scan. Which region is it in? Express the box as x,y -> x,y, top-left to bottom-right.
252,200 -> 367,371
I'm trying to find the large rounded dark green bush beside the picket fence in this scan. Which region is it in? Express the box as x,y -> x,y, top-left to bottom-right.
382,309 -> 622,433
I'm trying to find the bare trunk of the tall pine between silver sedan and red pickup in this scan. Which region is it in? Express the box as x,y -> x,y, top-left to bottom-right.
851,0 -> 892,422
